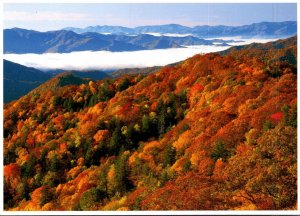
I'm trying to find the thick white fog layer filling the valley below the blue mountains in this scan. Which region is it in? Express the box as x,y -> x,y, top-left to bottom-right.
4,38 -> 276,70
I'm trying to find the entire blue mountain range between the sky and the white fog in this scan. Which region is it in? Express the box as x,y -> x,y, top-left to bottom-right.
4,21 -> 297,54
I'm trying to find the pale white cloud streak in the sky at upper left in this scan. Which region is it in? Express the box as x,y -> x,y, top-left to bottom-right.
3,11 -> 92,22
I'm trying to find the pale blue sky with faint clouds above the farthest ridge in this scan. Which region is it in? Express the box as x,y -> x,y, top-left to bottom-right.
3,3 -> 297,31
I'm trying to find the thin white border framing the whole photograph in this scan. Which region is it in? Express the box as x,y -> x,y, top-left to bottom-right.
0,0 -> 300,215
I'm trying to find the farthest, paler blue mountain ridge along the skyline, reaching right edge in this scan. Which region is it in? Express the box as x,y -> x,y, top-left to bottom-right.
64,21 -> 297,38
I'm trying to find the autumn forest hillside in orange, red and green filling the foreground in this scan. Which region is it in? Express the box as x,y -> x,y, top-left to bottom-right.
4,37 -> 297,210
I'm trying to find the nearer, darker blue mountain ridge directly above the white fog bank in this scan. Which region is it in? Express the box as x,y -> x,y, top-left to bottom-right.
4,28 -> 225,54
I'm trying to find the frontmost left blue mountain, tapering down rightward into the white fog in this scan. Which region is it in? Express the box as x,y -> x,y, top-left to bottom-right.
4,28 -> 141,54
